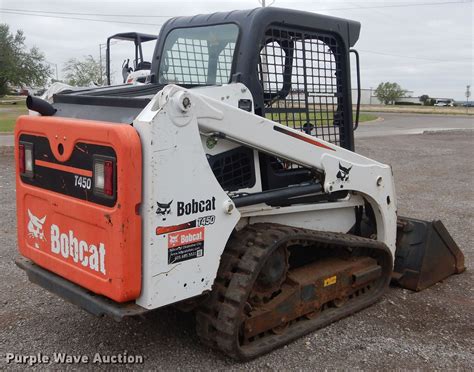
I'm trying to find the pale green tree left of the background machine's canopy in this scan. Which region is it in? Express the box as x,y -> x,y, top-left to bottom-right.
63,55 -> 106,87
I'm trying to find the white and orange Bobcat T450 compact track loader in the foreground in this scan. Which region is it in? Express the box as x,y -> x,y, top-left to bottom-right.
15,8 -> 464,360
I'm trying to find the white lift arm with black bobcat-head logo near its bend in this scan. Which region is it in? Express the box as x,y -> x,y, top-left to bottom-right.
146,84 -> 397,255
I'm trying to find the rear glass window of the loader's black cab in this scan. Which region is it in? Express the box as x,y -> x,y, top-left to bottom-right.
158,24 -> 239,85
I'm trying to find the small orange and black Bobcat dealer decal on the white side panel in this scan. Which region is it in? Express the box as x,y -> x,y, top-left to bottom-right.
168,227 -> 204,265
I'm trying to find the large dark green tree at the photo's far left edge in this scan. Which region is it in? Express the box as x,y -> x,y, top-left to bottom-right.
0,24 -> 51,96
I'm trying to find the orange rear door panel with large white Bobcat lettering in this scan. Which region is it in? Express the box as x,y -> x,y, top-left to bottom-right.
15,116 -> 142,302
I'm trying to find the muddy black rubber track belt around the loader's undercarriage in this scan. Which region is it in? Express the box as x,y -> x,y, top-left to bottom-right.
196,223 -> 392,360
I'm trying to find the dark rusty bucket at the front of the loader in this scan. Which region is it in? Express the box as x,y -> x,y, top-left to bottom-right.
392,217 -> 466,291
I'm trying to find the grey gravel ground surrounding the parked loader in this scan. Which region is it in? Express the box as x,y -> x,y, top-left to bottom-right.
0,132 -> 474,370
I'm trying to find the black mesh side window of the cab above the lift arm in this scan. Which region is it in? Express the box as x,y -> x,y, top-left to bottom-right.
258,28 -> 345,145
